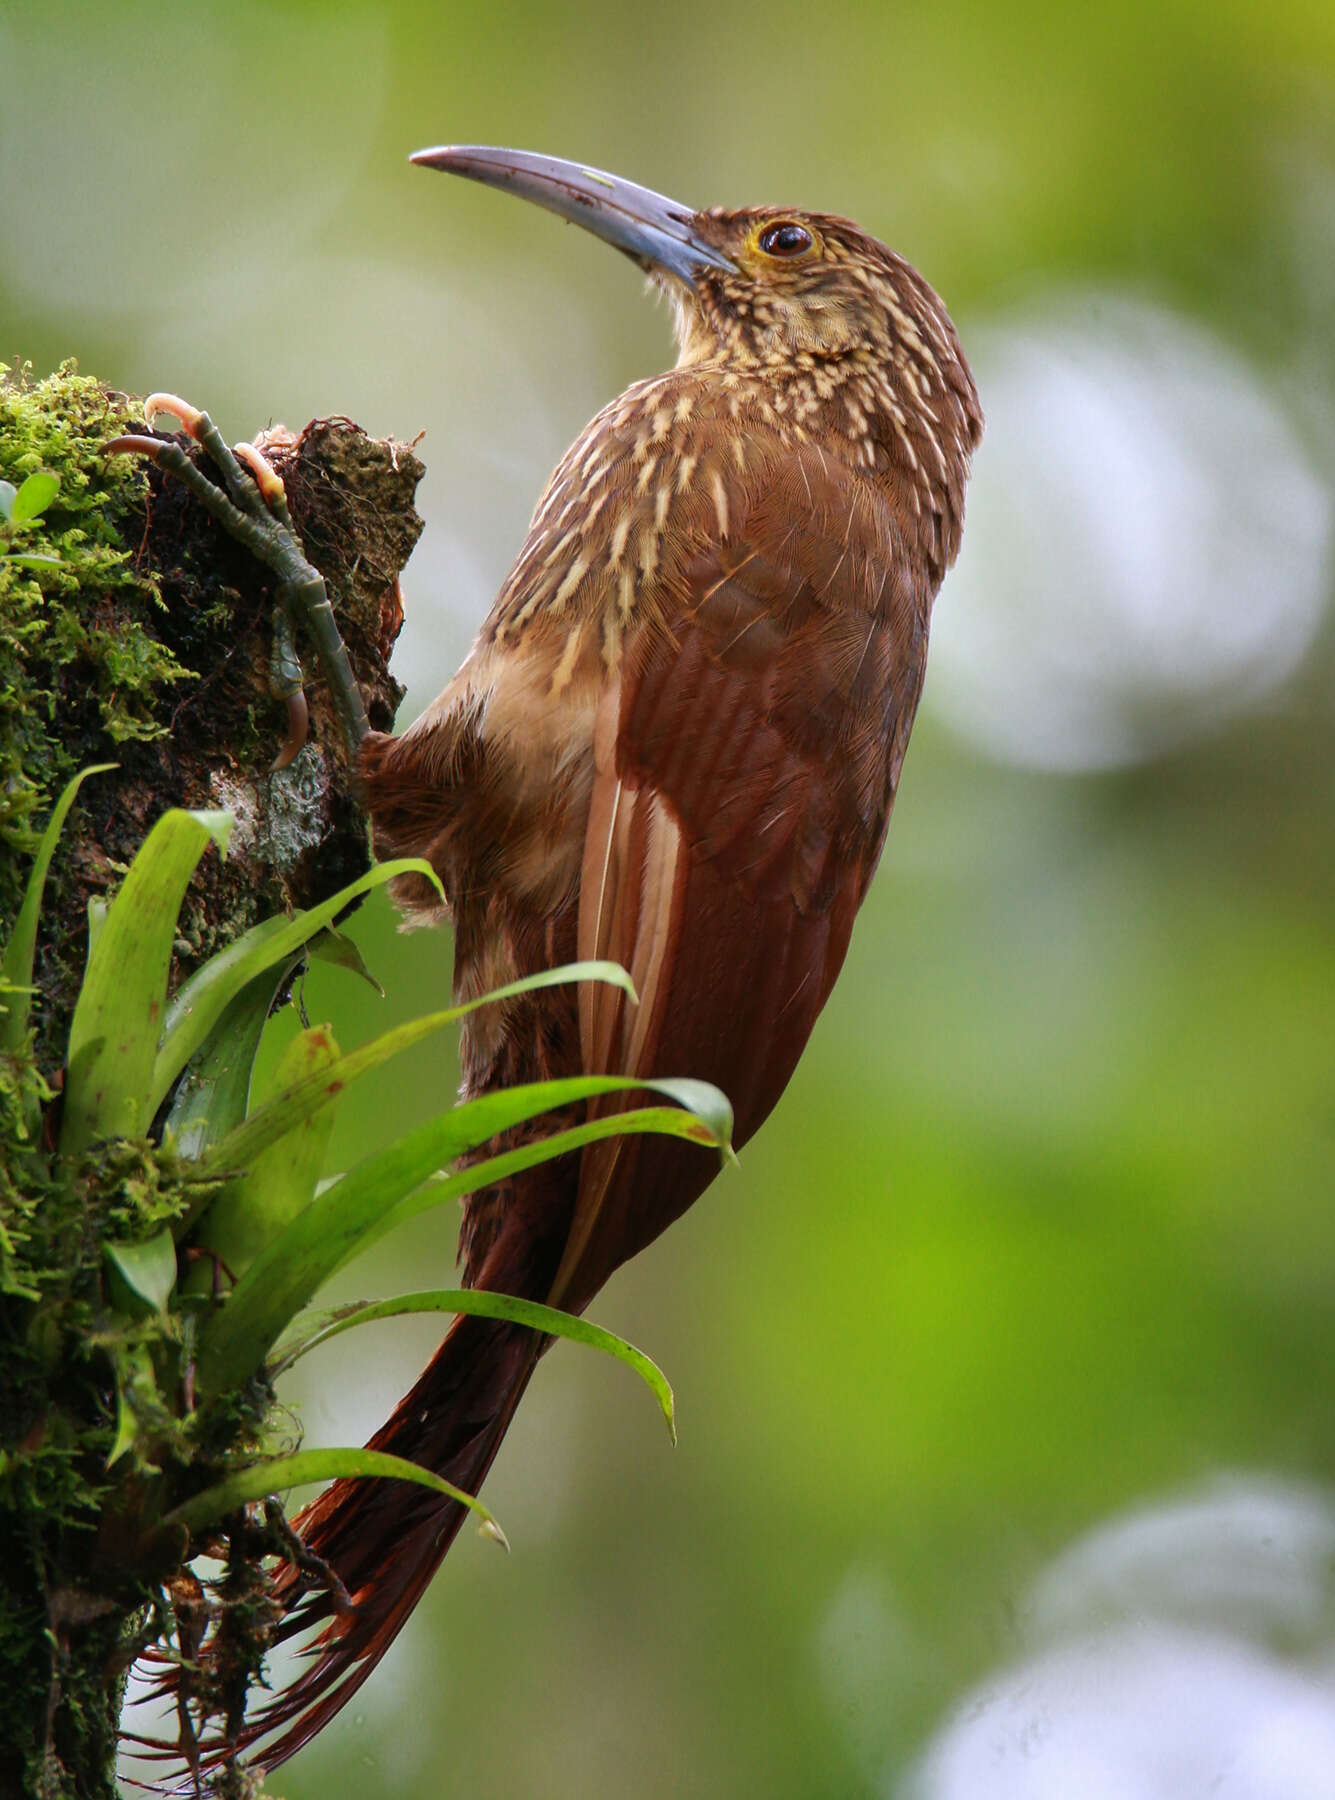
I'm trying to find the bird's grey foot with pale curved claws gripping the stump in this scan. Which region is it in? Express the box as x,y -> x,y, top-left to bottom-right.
106,394 -> 369,769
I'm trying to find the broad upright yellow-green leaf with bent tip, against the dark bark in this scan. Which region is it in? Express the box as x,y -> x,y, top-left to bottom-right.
61,810 -> 232,1156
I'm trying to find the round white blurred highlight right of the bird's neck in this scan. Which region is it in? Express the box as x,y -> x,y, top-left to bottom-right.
927,292 -> 1331,770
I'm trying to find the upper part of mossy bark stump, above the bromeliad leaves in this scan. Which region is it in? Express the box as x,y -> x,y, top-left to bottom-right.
0,365 -> 423,1053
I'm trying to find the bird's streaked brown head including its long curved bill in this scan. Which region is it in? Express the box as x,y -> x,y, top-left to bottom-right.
412,146 -> 982,511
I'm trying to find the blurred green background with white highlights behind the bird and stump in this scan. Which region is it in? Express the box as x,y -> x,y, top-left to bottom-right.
10,0 -> 1335,1800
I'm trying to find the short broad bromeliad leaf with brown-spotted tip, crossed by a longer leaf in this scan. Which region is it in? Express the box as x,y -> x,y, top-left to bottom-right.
198,1026 -> 338,1274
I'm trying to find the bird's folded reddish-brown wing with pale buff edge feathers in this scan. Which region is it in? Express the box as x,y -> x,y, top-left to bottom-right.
552,450 -> 927,1307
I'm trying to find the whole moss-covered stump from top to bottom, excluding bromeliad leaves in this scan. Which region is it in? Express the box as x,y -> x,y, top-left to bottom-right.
0,365 -> 421,1800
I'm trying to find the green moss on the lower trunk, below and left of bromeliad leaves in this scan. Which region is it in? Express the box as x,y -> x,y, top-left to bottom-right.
0,1101 -> 272,1800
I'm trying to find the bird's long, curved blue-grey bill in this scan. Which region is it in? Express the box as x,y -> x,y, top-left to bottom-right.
408,144 -> 736,286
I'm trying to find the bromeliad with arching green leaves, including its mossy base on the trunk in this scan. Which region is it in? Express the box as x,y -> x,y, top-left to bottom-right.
0,770 -> 730,1800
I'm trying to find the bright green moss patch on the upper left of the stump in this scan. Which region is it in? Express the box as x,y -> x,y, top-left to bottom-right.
0,362 -> 187,885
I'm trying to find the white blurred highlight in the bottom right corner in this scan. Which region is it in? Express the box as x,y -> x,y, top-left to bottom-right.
892,1478 -> 1335,1800
